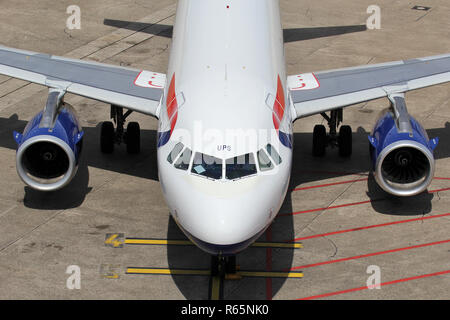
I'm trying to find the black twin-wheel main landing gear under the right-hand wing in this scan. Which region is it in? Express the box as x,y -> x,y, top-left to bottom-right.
312,109 -> 352,157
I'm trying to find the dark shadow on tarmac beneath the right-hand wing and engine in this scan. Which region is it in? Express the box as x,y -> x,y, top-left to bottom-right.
291,122 -> 450,219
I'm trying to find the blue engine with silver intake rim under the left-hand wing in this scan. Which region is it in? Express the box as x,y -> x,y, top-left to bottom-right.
14,91 -> 83,191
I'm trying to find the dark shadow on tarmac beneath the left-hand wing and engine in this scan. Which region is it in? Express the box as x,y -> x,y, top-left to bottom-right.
0,114 -> 158,210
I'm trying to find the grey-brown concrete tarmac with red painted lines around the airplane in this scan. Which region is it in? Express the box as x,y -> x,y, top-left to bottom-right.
0,0 -> 450,300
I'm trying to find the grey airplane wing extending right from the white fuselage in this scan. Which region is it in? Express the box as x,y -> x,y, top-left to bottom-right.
287,54 -> 450,120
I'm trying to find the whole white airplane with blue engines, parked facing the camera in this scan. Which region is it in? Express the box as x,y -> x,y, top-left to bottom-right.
0,0 -> 450,273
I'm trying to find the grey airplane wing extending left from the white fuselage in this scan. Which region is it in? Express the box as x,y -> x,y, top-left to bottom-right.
0,46 -> 166,117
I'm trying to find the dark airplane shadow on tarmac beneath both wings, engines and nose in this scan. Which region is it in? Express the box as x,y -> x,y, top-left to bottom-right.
0,114 -> 450,299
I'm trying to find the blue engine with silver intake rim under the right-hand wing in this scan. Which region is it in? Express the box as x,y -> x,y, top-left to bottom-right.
369,96 -> 439,196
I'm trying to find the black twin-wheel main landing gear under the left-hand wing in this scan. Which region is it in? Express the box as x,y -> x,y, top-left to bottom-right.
100,105 -> 141,154
